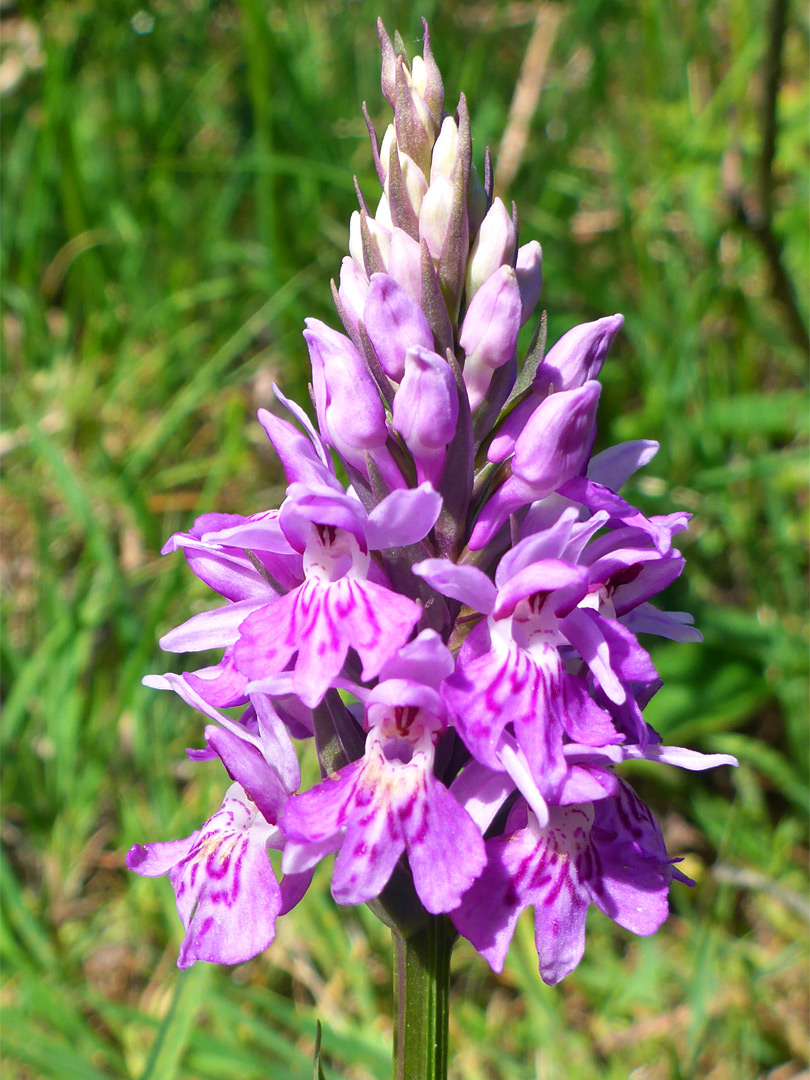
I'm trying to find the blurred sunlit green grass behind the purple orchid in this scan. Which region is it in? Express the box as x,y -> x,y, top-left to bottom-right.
0,0 -> 808,1080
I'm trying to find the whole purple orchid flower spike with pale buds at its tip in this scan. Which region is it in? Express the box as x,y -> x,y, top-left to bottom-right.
127,25 -> 733,983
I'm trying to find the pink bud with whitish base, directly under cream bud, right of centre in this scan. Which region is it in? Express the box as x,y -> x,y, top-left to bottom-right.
459,266 -> 521,410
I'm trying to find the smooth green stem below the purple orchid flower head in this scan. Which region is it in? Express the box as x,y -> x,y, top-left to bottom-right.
393,915 -> 456,1080
